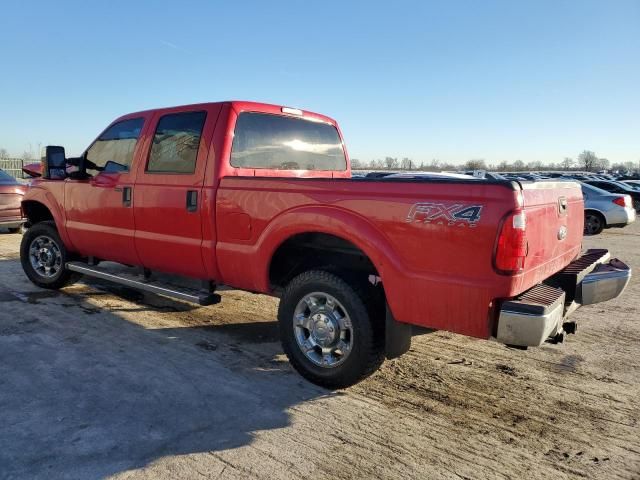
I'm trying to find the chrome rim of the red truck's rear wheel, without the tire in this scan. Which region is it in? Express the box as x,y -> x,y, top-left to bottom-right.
293,292 -> 353,368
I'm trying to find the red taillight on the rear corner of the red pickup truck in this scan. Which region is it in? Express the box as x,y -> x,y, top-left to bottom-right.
495,211 -> 527,274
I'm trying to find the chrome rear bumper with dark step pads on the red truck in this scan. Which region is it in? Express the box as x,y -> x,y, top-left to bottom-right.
496,250 -> 631,347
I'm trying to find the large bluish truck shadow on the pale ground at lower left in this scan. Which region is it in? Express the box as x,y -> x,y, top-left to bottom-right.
0,260 -> 330,479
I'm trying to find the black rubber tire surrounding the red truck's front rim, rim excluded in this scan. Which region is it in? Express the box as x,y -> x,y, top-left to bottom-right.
20,221 -> 81,290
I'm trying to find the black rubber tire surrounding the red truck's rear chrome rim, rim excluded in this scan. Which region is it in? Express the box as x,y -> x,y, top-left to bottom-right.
278,270 -> 384,389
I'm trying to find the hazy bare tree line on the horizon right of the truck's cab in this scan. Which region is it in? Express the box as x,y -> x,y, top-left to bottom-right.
351,150 -> 640,172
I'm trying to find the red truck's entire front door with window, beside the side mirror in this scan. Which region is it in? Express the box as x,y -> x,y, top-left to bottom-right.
64,114 -> 150,265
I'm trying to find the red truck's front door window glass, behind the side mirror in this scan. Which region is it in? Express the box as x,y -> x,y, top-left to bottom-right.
85,118 -> 144,171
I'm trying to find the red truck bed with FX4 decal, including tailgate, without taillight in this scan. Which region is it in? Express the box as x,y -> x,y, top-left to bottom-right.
216,177 -> 583,338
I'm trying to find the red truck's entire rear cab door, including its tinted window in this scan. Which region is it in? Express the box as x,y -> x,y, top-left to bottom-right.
133,106 -> 220,278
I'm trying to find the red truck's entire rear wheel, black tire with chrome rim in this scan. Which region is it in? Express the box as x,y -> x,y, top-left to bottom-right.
278,270 -> 384,388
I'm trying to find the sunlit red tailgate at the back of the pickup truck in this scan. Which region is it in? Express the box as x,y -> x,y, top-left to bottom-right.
518,181 -> 584,291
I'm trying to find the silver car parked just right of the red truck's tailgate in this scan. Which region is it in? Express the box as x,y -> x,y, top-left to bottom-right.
580,183 -> 636,235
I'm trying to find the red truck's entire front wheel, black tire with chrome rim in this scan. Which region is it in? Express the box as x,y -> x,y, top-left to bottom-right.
20,222 -> 79,290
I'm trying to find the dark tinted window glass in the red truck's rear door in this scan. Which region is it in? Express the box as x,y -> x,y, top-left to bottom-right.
147,112 -> 207,173
